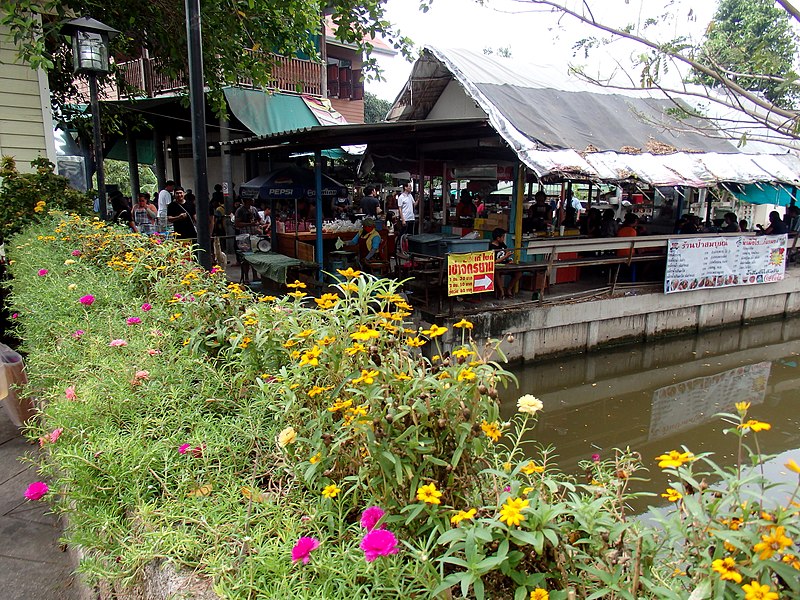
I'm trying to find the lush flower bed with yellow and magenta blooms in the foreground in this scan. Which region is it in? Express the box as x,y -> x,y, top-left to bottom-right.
10,215 -> 800,599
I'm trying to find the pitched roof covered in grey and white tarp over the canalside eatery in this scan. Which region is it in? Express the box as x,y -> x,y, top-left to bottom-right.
389,46 -> 800,187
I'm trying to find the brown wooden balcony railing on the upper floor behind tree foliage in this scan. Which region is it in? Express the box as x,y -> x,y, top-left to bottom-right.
117,55 -> 322,98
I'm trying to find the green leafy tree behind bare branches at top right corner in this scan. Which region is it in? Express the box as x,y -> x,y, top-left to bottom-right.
697,0 -> 798,108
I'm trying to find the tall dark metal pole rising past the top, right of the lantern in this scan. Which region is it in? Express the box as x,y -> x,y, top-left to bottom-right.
184,0 -> 211,270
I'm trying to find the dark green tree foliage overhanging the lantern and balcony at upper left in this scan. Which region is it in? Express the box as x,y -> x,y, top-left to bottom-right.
0,0 -> 410,119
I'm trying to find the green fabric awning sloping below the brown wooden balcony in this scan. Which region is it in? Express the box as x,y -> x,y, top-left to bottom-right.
225,87 -> 319,135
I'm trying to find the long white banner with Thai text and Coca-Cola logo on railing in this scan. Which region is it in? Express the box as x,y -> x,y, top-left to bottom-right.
664,235 -> 786,294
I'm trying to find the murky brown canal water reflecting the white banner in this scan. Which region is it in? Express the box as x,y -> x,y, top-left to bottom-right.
510,318 -> 800,508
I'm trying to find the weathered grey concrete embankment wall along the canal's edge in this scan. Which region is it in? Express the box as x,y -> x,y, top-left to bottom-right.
443,270 -> 800,361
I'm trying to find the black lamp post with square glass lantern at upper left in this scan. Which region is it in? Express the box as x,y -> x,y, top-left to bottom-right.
61,17 -> 119,220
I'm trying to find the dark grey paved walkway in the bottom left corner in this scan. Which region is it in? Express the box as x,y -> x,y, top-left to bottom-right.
0,411 -> 80,600
